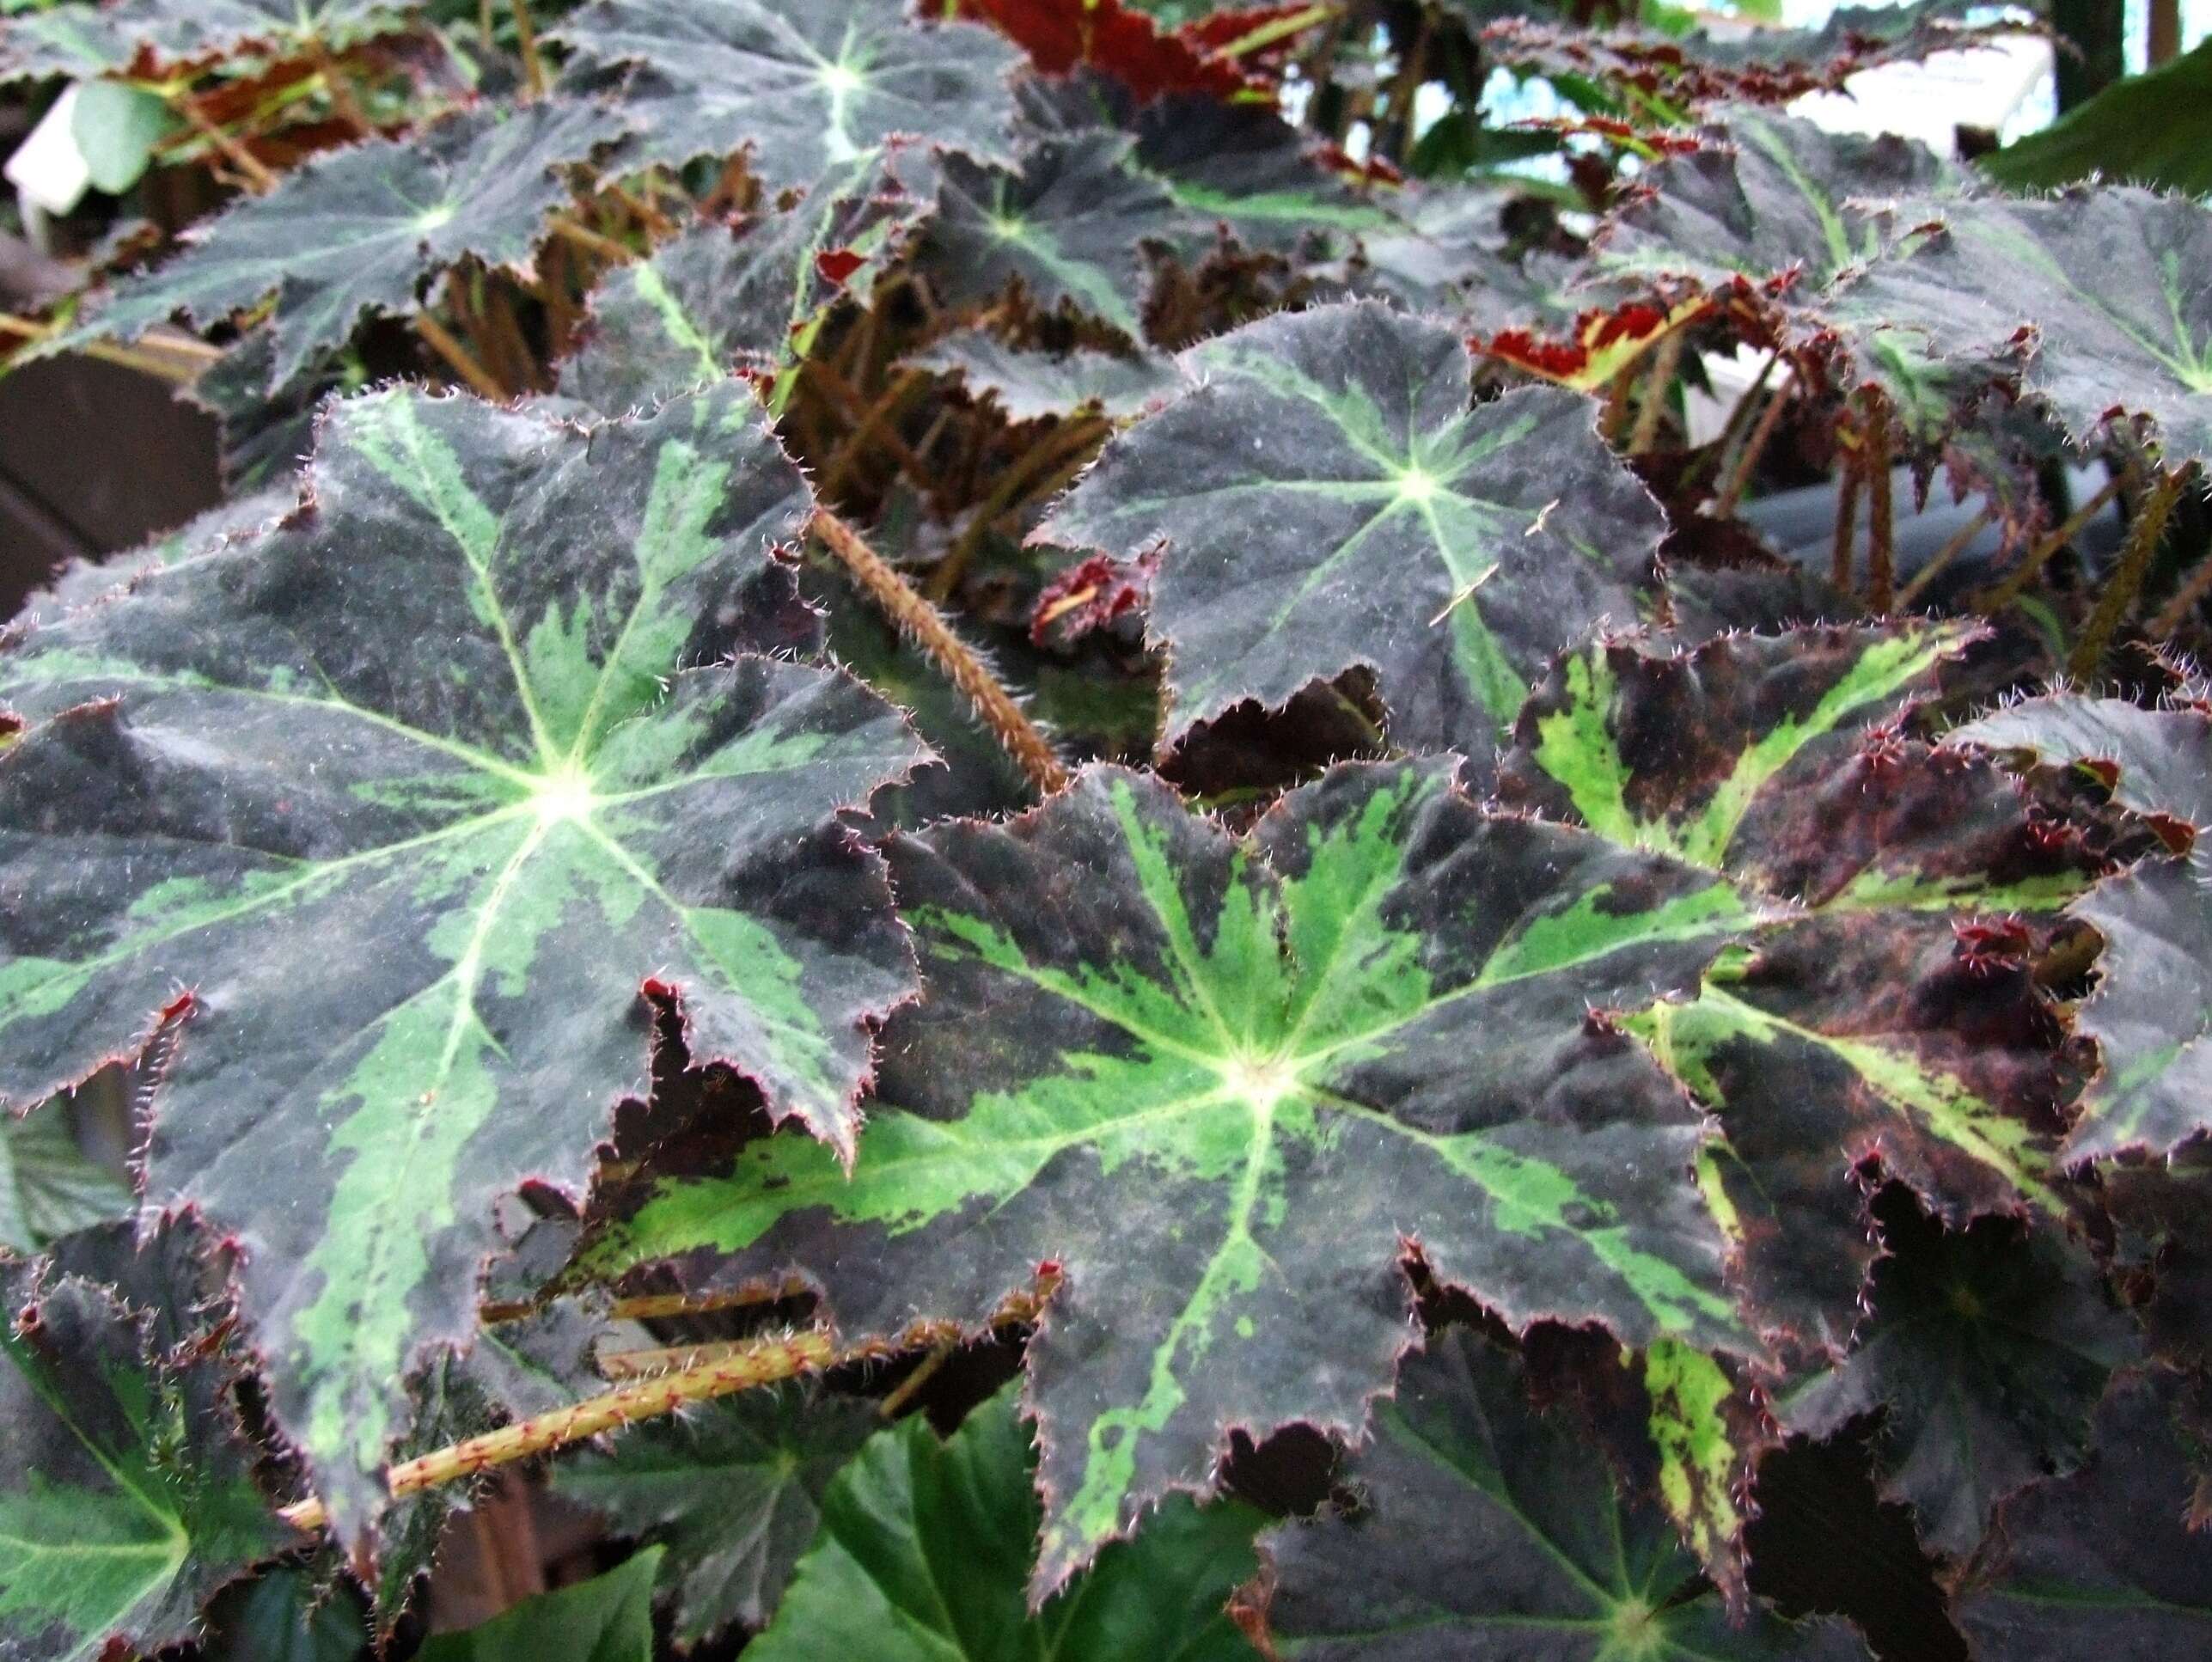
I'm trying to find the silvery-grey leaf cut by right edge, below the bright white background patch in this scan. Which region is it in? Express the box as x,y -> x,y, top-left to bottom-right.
1838,188 -> 2212,467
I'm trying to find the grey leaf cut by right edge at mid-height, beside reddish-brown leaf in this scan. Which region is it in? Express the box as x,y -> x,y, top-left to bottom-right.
1949,695 -> 2212,1158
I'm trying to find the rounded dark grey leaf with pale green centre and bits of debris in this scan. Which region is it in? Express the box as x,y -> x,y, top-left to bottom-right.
1037,303 -> 1665,748
